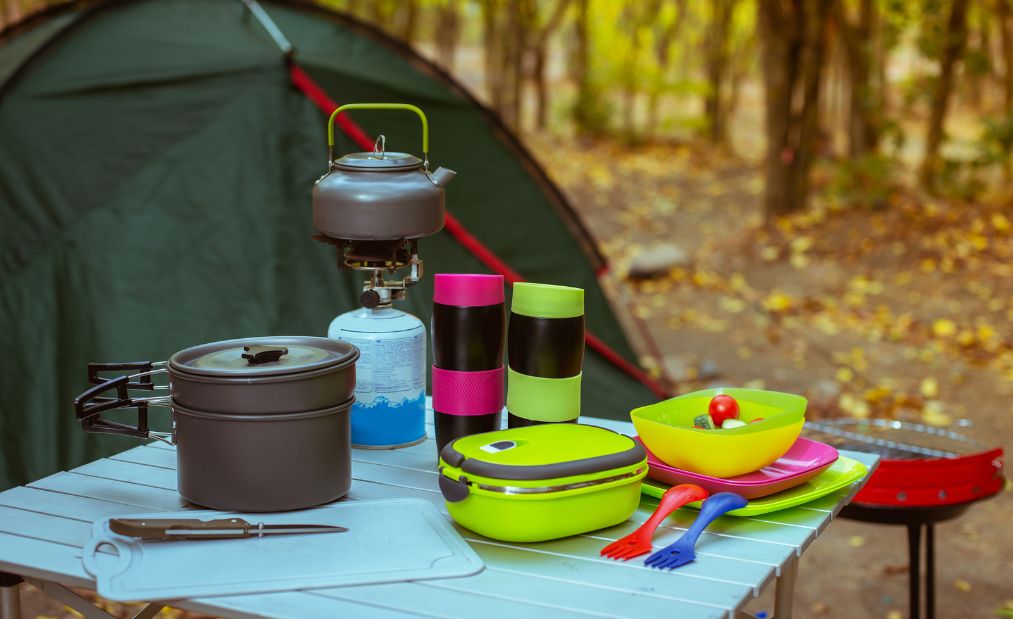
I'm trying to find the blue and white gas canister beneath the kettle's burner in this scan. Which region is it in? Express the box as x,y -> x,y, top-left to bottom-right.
327,307 -> 426,449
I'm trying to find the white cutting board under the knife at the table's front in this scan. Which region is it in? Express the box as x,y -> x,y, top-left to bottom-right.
82,498 -> 483,602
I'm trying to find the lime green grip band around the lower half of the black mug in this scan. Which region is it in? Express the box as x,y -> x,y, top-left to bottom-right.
507,368 -> 582,421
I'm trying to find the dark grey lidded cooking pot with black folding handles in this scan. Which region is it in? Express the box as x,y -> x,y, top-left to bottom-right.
74,336 -> 359,512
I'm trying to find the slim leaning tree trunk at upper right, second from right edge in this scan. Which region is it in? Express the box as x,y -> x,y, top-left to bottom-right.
919,0 -> 967,190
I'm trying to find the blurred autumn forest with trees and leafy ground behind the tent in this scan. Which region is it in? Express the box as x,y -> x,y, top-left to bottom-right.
0,0 -> 1013,619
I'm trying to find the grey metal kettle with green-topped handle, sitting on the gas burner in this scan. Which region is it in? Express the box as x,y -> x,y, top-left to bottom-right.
313,103 -> 456,245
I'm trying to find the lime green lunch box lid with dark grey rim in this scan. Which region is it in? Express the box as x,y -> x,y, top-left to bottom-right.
440,423 -> 647,483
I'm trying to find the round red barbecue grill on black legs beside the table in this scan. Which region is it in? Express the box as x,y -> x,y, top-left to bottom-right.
805,418 -> 1006,619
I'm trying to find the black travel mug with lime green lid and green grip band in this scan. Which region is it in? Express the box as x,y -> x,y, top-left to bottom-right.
507,283 -> 583,428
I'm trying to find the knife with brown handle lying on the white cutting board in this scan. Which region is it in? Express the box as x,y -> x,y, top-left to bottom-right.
109,518 -> 347,540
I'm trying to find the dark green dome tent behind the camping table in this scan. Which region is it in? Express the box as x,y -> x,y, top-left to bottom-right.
0,0 -> 654,487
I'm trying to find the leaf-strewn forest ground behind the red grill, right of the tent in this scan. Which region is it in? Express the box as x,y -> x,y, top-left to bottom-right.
531,131 -> 1013,427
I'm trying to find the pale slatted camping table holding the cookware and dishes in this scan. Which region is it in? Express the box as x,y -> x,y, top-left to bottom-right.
0,413 -> 879,619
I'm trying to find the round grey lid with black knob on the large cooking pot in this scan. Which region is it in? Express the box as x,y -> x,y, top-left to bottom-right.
169,335 -> 359,378
